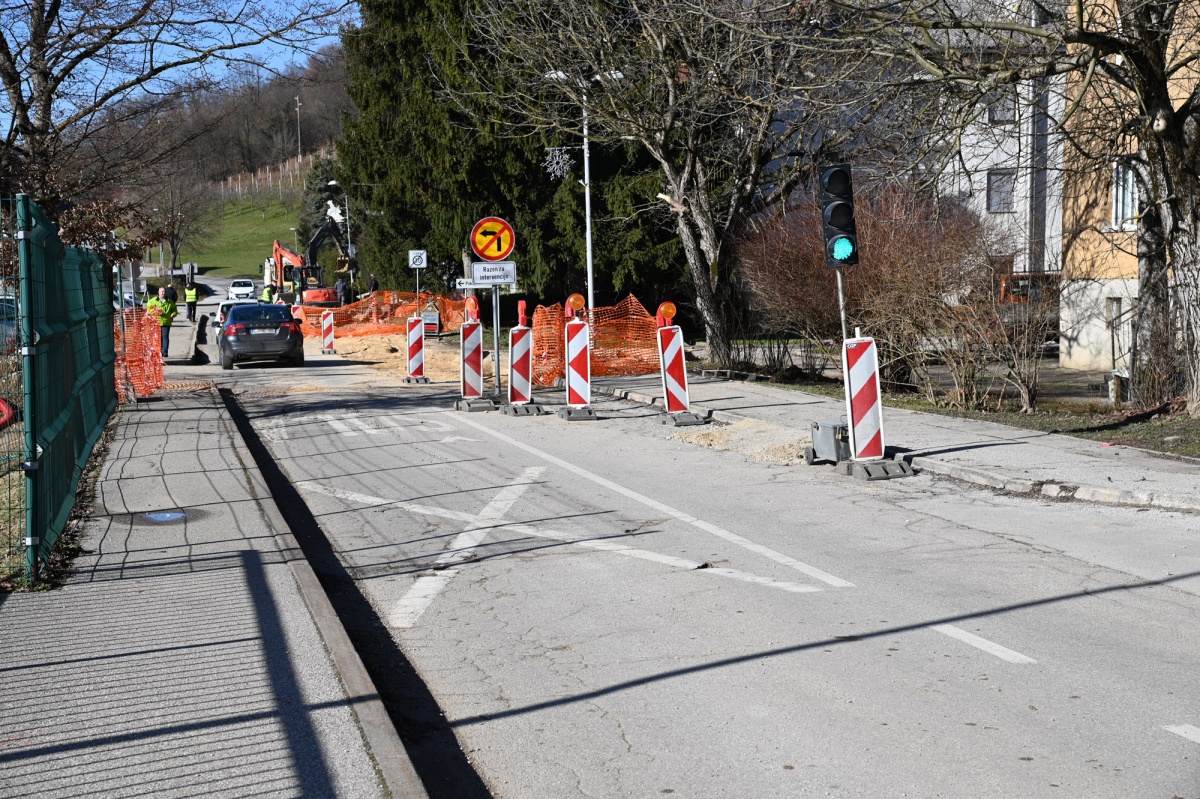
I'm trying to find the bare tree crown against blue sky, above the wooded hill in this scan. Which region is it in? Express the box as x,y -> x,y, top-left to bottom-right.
0,0 -> 348,216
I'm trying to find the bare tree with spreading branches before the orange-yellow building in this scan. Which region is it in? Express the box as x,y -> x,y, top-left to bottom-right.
763,0 -> 1200,415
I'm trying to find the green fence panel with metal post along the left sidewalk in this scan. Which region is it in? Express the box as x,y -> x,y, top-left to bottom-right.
0,196 -> 116,581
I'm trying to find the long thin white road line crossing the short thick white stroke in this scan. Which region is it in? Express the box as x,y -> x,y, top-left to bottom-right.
296,482 -> 821,590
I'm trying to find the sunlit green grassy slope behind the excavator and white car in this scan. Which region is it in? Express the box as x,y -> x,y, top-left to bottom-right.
179,203 -> 299,278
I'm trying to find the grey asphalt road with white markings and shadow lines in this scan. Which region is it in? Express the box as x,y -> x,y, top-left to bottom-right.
194,343 -> 1200,799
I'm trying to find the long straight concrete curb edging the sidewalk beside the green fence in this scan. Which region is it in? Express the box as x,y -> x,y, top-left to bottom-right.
221,386 -> 428,799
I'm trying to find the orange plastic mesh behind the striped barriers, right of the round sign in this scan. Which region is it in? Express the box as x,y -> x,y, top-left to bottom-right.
533,294 -> 659,385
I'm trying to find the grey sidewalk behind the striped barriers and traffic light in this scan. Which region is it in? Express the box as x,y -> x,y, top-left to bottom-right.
593,374 -> 1200,511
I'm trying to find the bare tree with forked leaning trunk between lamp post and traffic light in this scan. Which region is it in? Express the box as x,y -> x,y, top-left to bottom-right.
458,0 -> 898,364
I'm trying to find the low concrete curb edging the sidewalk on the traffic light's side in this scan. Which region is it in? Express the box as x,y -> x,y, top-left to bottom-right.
592,376 -> 1200,511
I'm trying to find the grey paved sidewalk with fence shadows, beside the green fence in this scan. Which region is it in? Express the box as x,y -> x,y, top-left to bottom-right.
0,364 -> 425,798
